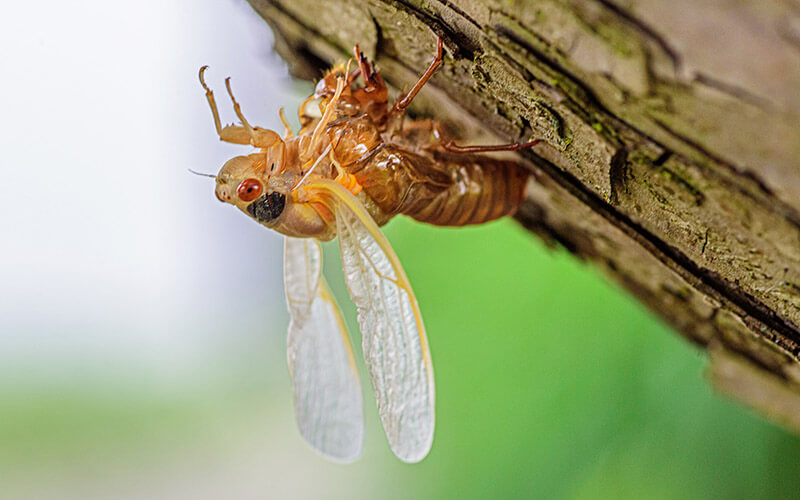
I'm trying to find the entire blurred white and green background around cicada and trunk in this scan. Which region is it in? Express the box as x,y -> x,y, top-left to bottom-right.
0,0 -> 800,499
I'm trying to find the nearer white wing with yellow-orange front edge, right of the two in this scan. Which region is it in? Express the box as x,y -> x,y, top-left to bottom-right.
306,180 -> 434,462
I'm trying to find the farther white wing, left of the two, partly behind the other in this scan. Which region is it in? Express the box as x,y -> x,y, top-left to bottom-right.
283,238 -> 364,462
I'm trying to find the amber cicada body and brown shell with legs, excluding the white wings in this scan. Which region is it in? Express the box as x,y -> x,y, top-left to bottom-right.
200,39 -> 537,240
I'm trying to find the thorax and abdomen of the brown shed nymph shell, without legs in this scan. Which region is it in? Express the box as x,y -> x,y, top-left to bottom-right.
328,114 -> 529,226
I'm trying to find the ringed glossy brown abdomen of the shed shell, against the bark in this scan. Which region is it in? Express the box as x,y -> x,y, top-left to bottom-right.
348,144 -> 529,226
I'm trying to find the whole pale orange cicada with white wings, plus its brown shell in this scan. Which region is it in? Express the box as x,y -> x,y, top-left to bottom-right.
200,38 -> 536,462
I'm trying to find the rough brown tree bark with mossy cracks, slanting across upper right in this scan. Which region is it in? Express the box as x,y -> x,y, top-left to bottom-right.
250,0 -> 800,429
